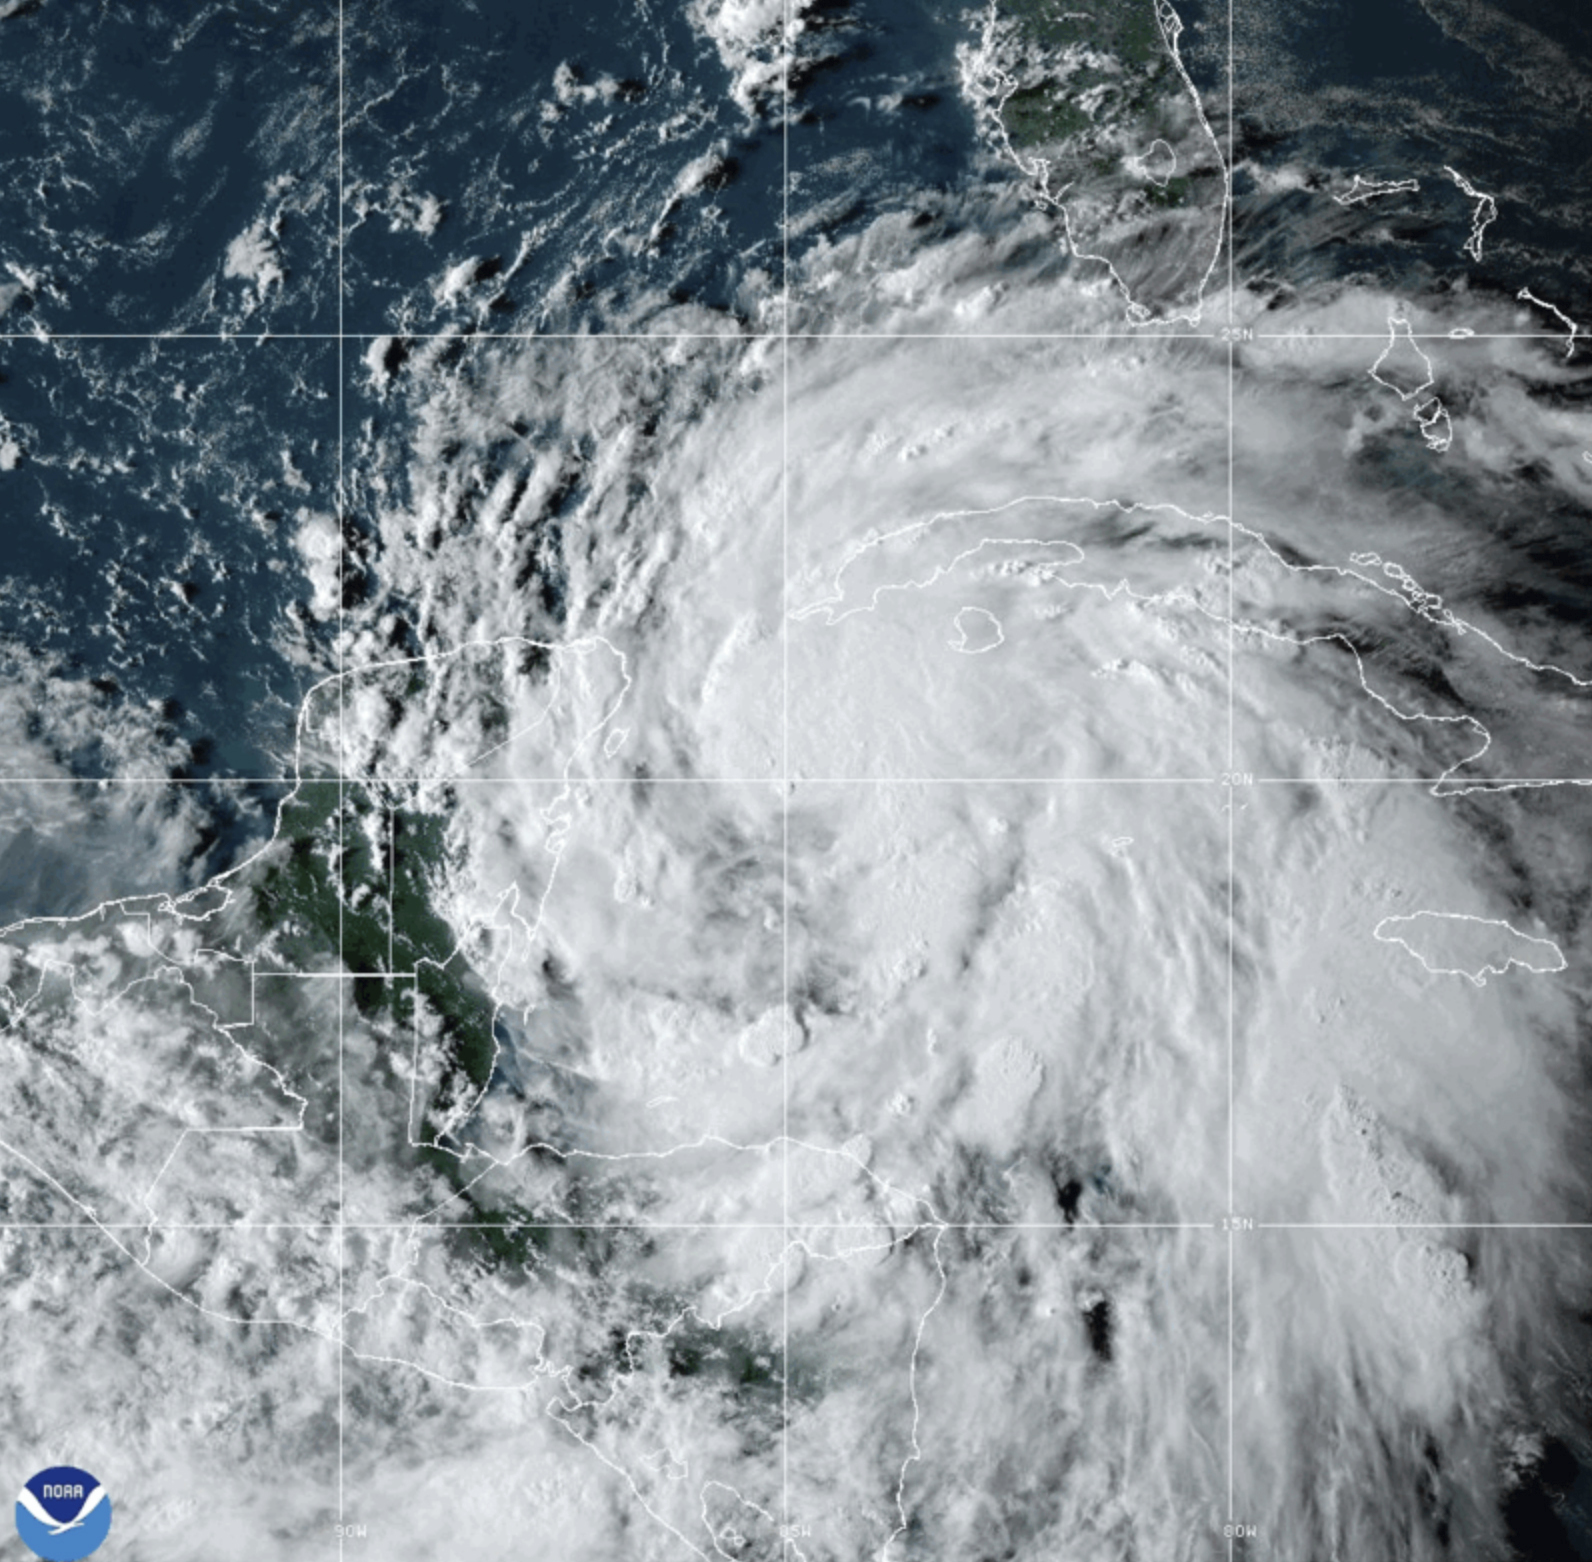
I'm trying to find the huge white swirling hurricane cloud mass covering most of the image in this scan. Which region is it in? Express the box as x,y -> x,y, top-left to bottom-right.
0,6 -> 1592,1559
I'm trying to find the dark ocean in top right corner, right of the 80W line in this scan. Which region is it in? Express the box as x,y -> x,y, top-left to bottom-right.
1235,0 -> 1592,328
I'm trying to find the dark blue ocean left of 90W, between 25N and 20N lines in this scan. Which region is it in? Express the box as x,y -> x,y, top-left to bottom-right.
0,341 -> 338,775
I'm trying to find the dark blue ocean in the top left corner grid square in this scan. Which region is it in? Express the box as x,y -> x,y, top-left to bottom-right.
0,0 -> 338,331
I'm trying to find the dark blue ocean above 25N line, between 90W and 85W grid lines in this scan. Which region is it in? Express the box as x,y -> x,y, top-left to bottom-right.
345,0 -> 783,333
